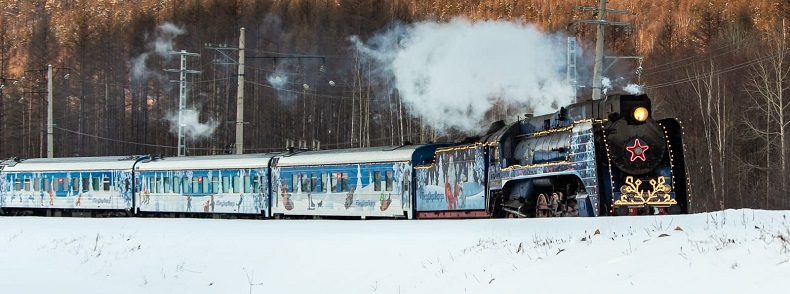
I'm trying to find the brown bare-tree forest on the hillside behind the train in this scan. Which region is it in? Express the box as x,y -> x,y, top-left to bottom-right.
0,0 -> 790,211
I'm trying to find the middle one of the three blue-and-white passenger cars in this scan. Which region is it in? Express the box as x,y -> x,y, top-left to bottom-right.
135,154 -> 272,217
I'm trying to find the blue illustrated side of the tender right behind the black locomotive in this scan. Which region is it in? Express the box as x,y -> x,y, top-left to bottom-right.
415,144 -> 485,211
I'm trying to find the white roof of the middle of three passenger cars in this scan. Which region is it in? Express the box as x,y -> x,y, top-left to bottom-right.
135,153 -> 276,171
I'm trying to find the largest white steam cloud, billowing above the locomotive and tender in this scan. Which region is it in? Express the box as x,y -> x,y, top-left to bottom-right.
351,18 -> 574,132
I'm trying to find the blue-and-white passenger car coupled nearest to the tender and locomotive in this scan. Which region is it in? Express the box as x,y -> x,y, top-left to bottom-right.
272,144 -> 444,218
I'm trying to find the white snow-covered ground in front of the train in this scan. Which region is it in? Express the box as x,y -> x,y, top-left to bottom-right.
0,210 -> 790,294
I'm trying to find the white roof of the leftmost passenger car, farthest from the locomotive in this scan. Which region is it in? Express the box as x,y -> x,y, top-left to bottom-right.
0,156 -> 139,172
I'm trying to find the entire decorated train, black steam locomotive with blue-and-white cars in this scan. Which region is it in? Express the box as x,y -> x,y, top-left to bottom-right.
0,94 -> 691,219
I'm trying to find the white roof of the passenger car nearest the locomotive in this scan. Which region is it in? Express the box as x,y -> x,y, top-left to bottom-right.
277,144 -> 447,167
